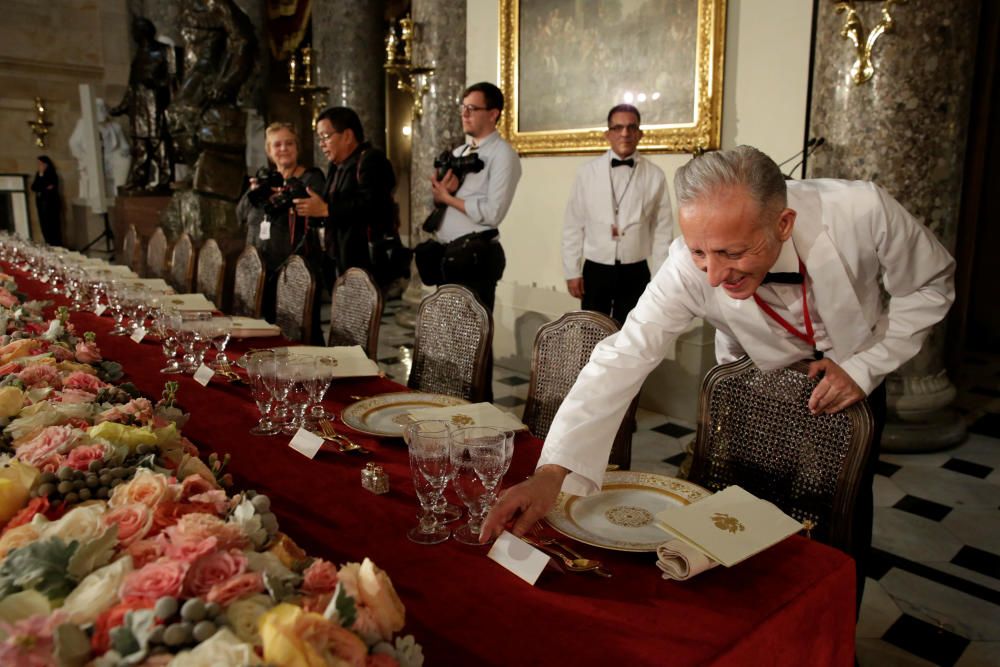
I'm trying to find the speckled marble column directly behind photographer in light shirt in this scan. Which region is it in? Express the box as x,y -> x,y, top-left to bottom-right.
396,0 -> 466,326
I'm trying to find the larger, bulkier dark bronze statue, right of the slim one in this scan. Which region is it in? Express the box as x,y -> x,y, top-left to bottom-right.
167,0 -> 257,201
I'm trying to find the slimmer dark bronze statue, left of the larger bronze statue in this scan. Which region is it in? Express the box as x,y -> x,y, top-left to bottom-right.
109,16 -> 176,194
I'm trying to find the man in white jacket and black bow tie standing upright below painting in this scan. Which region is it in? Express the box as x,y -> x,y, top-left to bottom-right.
562,104 -> 673,323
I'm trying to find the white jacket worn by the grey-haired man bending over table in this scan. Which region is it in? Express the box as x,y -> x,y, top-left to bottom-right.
538,179 -> 955,495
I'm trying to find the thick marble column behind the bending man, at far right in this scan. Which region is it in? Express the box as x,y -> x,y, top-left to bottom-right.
808,0 -> 978,451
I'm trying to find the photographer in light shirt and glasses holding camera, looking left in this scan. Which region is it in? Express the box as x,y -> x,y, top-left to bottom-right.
418,82 -> 521,310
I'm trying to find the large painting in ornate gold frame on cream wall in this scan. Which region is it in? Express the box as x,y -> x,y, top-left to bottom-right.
500,0 -> 726,155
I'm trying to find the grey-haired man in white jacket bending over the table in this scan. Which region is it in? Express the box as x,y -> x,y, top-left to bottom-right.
482,146 -> 955,604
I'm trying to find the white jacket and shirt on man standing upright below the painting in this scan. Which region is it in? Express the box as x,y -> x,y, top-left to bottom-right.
562,150 -> 674,280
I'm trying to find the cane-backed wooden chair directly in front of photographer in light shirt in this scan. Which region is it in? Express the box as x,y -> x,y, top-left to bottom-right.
407,285 -> 493,403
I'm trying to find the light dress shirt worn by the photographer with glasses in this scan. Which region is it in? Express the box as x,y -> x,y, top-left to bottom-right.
437,130 -> 521,243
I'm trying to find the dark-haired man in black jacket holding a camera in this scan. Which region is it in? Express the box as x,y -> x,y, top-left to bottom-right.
295,107 -> 396,288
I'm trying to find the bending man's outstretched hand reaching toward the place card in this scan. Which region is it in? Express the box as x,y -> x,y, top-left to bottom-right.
479,465 -> 569,542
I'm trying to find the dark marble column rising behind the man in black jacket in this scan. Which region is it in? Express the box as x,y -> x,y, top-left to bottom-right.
312,0 -> 385,151
